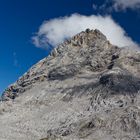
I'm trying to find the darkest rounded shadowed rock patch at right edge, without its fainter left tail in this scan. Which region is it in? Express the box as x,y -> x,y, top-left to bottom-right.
100,74 -> 140,95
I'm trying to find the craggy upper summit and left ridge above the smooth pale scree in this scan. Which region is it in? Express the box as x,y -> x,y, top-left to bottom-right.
2,29 -> 137,100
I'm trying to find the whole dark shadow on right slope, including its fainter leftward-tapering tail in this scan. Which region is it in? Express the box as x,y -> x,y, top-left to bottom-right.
62,74 -> 140,101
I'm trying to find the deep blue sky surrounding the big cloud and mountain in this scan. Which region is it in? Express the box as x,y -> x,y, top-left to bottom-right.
0,0 -> 140,92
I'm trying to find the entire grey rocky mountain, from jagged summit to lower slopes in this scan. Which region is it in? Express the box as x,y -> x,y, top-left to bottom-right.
0,29 -> 140,140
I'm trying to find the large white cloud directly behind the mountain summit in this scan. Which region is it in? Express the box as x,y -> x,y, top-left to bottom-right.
33,14 -> 137,47
